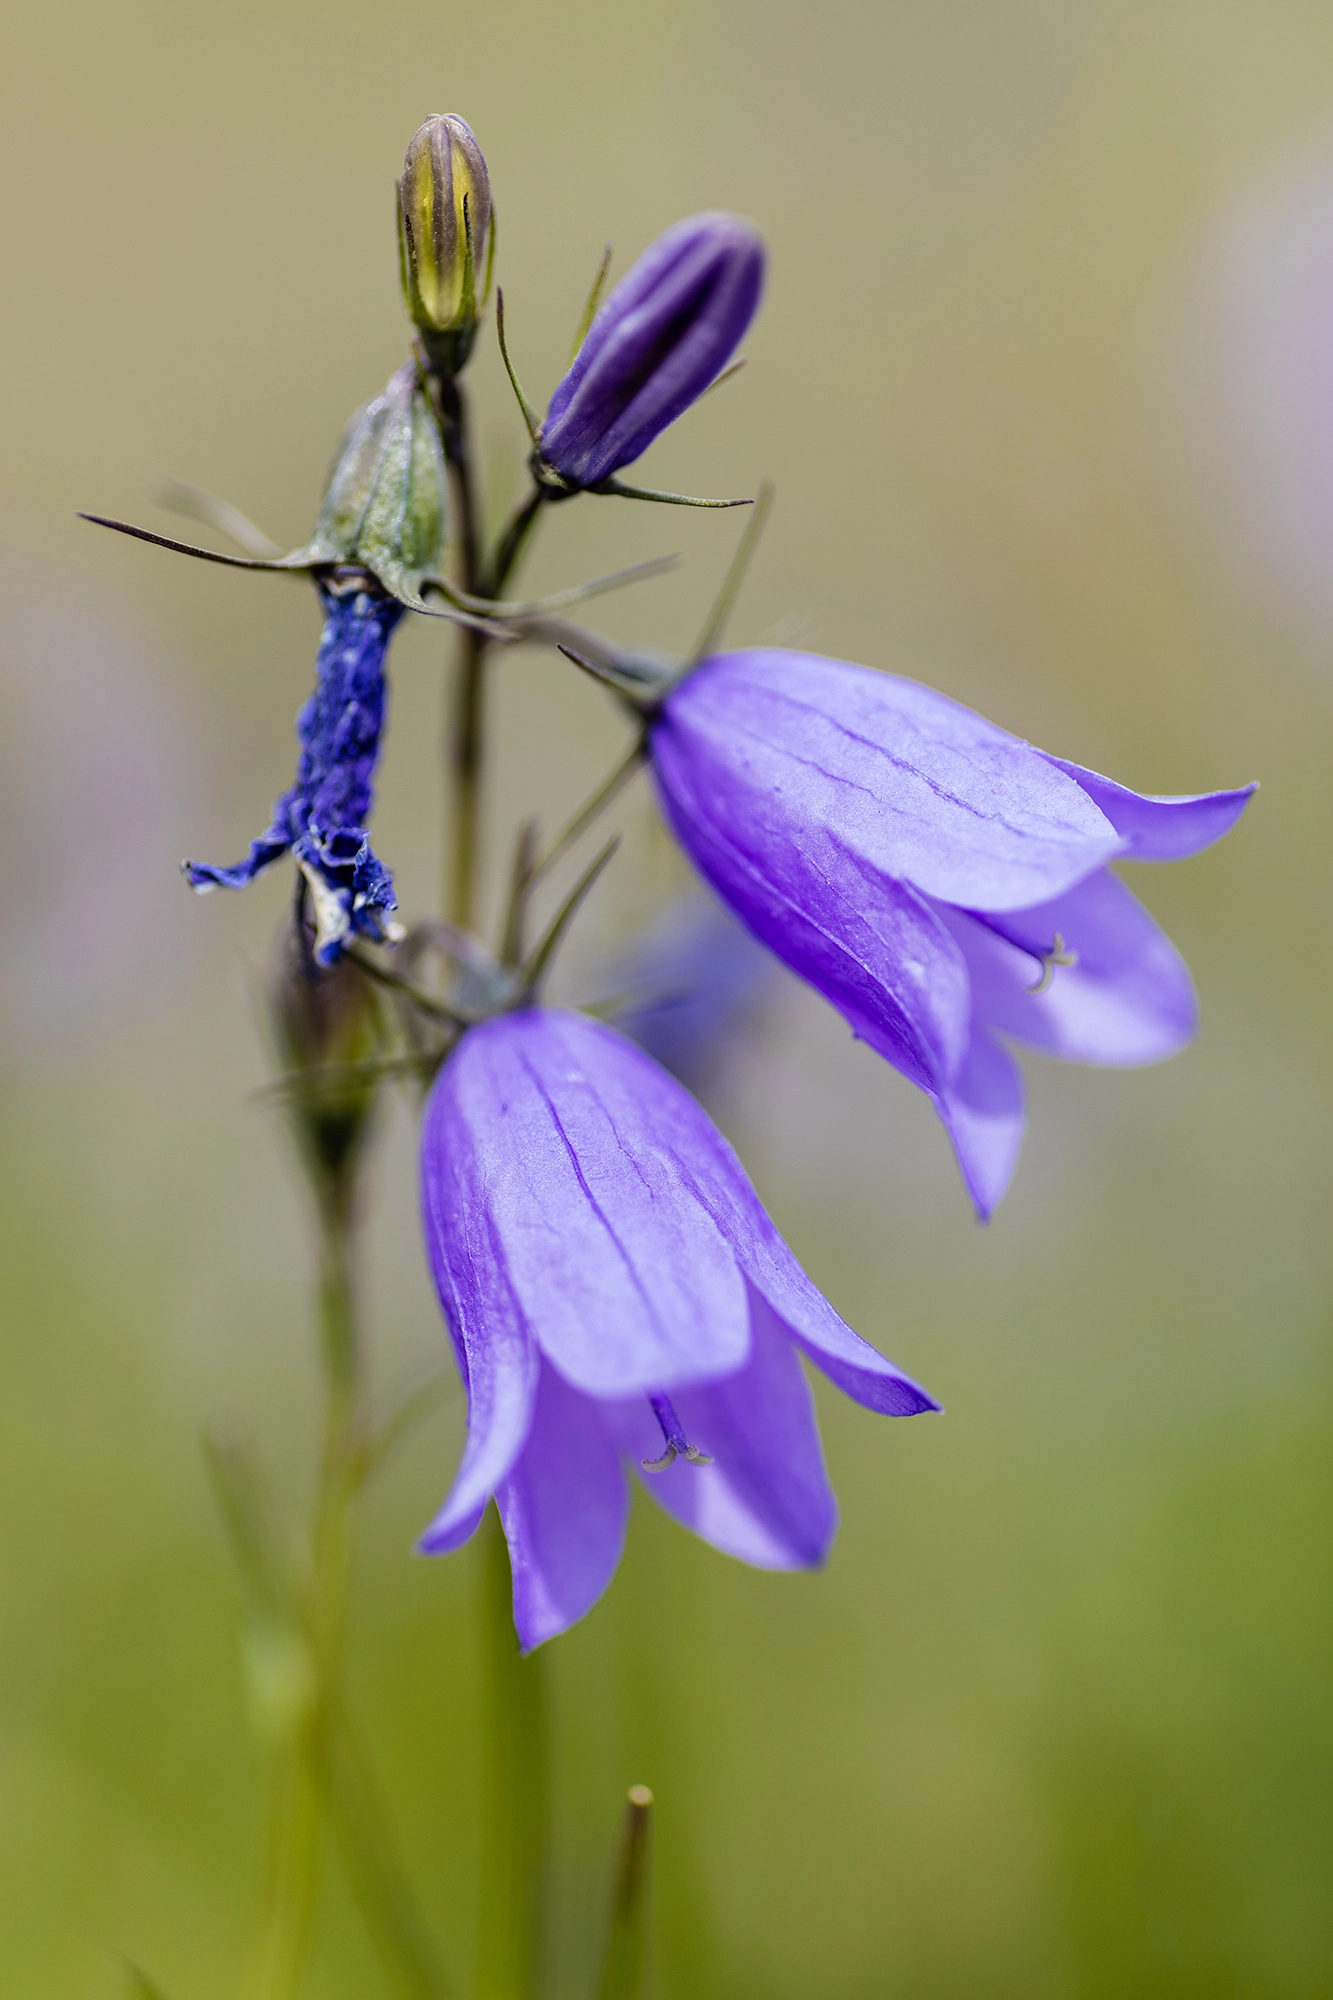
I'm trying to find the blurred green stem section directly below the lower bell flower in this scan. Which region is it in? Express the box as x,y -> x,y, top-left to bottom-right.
476,1506 -> 546,2000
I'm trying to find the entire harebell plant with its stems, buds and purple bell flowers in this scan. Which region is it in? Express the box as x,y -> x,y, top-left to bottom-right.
90,112 -> 1253,2000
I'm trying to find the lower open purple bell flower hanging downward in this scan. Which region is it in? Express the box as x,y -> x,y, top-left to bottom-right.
420,1010 -> 937,1648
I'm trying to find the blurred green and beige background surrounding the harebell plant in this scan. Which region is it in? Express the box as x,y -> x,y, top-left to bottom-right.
0,0 -> 1333,2000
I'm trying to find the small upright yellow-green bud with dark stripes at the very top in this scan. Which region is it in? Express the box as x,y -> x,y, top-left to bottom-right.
398,112 -> 494,374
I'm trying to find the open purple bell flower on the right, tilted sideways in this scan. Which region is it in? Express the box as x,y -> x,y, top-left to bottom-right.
648,650 -> 1253,1218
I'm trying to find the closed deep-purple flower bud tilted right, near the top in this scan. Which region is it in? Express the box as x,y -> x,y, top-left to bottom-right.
538,212 -> 765,490
